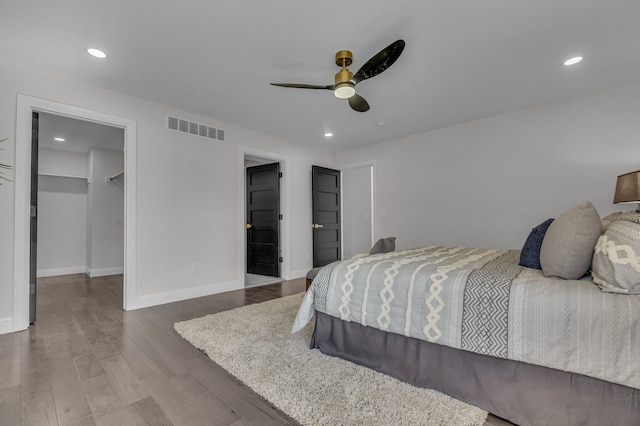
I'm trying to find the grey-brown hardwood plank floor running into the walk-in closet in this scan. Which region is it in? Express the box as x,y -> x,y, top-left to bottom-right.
0,274 -> 510,426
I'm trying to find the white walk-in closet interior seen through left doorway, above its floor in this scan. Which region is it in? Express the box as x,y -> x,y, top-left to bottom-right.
30,112 -> 125,322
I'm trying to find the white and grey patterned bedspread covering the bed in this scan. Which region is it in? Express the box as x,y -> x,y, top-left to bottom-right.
292,246 -> 640,389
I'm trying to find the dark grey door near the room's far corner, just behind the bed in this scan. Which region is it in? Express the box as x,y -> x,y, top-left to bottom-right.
311,166 -> 342,268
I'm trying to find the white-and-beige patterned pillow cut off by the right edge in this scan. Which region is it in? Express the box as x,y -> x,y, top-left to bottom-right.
592,214 -> 640,294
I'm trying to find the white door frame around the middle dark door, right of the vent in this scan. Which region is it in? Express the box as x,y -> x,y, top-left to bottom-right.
237,146 -> 291,287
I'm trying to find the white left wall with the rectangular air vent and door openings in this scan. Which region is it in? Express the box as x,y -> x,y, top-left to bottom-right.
0,57 -> 332,331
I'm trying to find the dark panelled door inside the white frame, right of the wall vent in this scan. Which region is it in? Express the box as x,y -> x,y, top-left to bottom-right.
246,163 -> 280,277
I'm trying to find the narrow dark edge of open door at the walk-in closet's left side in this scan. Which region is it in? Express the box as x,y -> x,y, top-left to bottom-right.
29,112 -> 38,324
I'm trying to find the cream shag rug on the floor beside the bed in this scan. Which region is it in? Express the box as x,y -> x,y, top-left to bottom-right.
174,293 -> 487,426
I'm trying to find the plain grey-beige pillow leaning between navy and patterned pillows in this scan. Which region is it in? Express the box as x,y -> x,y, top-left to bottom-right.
540,201 -> 602,280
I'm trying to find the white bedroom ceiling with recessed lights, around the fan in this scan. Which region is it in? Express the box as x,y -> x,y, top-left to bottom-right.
0,0 -> 640,151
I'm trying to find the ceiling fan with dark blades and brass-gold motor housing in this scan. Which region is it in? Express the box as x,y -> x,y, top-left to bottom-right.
271,40 -> 405,112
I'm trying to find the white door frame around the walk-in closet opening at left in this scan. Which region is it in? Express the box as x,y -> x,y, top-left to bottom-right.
12,93 -> 137,331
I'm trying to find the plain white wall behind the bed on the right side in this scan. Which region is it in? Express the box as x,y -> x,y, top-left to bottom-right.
335,84 -> 640,248
